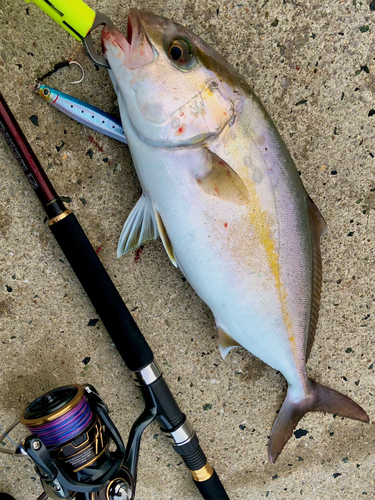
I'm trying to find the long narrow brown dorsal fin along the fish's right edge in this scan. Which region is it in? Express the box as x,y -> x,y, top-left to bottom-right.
305,196 -> 327,361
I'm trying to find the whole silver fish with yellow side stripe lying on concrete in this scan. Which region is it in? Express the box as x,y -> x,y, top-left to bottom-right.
102,9 -> 369,463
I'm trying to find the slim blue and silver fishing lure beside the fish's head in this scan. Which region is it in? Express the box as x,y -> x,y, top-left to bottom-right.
36,84 -> 127,144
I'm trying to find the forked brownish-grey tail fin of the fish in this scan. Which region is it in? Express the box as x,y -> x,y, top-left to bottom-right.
268,380 -> 369,463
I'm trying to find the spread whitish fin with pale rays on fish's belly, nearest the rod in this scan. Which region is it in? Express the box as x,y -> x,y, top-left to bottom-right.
117,194 -> 159,258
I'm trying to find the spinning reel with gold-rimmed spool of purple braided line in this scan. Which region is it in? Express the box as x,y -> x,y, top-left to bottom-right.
20,385 -> 135,500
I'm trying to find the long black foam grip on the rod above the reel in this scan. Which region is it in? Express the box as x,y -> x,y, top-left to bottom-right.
50,213 -> 153,371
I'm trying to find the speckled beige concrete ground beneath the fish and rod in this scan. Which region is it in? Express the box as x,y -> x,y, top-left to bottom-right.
0,0 -> 375,500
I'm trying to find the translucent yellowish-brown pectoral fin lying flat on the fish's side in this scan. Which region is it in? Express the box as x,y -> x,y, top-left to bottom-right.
197,150 -> 249,205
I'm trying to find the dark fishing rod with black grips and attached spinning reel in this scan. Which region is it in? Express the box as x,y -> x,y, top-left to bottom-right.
0,94 -> 229,500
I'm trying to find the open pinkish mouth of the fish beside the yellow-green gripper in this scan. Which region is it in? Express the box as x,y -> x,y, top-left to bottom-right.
102,9 -> 155,70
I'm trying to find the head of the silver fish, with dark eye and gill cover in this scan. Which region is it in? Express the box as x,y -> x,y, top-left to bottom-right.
102,9 -> 234,147
